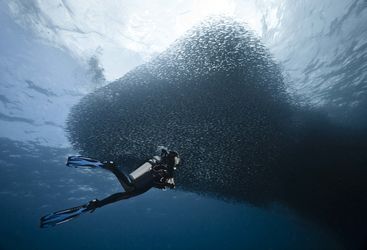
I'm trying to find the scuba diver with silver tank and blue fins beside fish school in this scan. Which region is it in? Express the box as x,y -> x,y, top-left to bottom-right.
40,148 -> 180,228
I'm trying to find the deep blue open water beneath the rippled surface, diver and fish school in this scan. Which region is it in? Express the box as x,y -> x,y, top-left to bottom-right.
0,139 -> 343,249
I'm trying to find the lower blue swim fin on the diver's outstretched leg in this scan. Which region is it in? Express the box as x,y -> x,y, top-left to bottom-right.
40,201 -> 95,228
